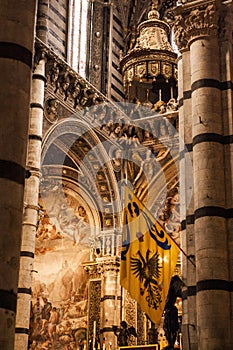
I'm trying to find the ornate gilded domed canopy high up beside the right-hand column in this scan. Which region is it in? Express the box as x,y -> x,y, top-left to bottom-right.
120,3 -> 177,105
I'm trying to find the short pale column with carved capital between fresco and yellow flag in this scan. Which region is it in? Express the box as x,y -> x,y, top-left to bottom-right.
83,255 -> 122,350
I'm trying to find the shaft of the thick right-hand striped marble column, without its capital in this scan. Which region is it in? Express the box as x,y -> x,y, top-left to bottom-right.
190,27 -> 230,350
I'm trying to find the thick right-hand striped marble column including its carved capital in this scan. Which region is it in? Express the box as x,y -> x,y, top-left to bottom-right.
176,1 -> 232,350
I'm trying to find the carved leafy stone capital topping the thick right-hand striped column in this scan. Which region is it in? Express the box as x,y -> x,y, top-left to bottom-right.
174,1 -> 218,51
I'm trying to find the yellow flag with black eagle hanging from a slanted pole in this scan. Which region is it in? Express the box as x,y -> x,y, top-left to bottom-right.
120,186 -> 179,325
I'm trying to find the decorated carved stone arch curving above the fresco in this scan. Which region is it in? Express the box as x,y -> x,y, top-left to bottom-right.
41,118 -> 120,230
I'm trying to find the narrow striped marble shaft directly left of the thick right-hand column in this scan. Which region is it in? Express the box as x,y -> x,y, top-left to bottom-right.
178,47 -> 197,350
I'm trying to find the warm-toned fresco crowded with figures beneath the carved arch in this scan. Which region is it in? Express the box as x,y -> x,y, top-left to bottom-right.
29,191 -> 90,350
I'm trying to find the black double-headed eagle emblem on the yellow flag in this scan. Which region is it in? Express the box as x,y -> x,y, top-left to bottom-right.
130,249 -> 162,309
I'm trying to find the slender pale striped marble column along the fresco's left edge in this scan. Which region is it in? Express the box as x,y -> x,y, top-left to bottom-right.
15,53 -> 46,350
